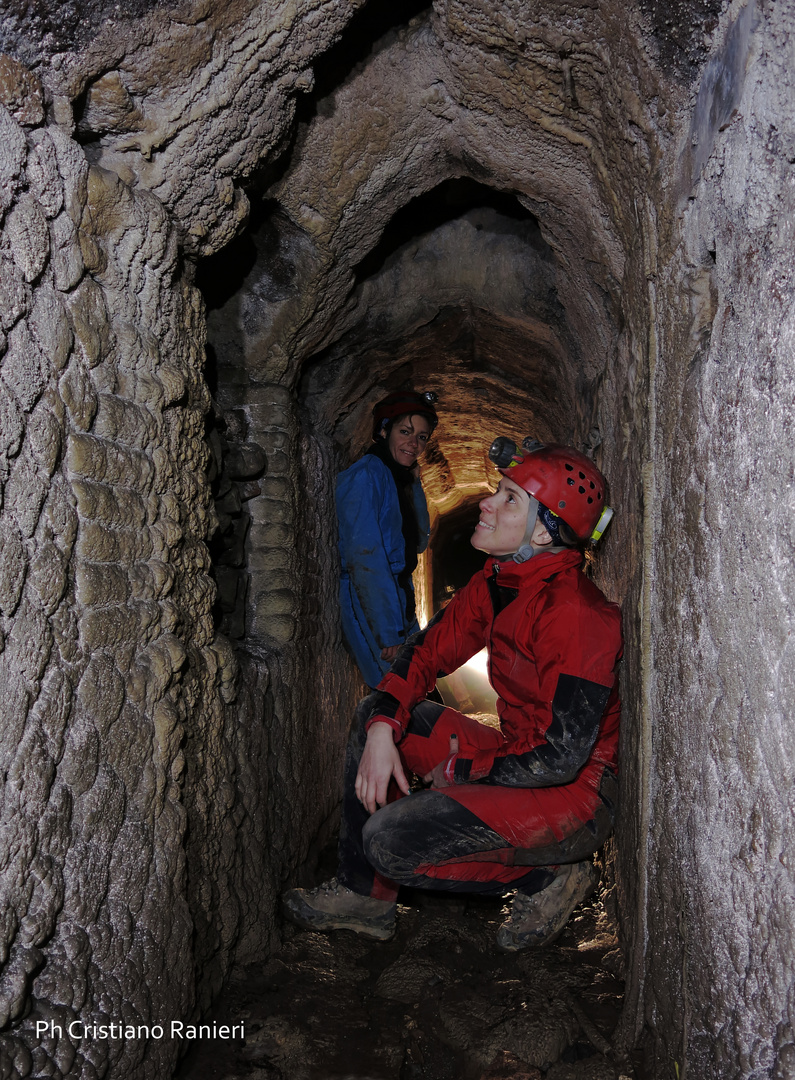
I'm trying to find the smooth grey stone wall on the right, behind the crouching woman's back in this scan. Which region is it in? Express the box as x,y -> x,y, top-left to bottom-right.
646,3 -> 795,1080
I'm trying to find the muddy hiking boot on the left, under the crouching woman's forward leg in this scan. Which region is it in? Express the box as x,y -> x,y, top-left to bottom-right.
282,878 -> 398,942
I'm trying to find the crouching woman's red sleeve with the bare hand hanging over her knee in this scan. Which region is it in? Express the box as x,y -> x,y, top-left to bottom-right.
368,573 -> 491,739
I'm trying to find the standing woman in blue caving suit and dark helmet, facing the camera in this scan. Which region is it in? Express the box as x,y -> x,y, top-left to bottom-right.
337,390 -> 437,687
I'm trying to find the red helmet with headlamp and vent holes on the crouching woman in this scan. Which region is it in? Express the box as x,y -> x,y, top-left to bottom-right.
489,440 -> 605,540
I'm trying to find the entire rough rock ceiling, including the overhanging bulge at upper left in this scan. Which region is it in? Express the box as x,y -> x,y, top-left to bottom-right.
10,0 -> 716,509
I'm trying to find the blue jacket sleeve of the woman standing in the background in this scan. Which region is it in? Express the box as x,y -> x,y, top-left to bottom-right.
337,456 -> 406,649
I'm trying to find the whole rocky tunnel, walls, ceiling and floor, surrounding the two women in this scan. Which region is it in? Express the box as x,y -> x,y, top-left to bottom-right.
0,0 -> 795,1080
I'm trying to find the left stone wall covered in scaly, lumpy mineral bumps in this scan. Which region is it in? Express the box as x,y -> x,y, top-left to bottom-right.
0,71 -> 268,1077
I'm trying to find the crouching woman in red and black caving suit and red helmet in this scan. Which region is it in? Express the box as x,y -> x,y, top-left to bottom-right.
284,438 -> 621,950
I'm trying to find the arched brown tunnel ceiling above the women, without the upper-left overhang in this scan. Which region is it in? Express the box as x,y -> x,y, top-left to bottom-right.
189,0 -> 683,510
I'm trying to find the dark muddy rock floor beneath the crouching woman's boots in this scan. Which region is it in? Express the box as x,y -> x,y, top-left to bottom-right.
173,872 -> 643,1080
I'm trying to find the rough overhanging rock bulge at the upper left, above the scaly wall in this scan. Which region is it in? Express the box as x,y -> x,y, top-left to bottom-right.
29,0 -> 363,255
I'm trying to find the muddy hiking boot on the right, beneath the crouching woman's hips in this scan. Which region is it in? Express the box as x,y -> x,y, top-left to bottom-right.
497,862 -> 598,953
